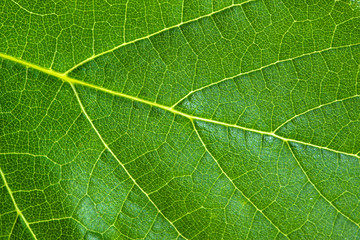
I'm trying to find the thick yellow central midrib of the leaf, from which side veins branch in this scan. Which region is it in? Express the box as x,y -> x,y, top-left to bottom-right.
0,53 -> 359,158
